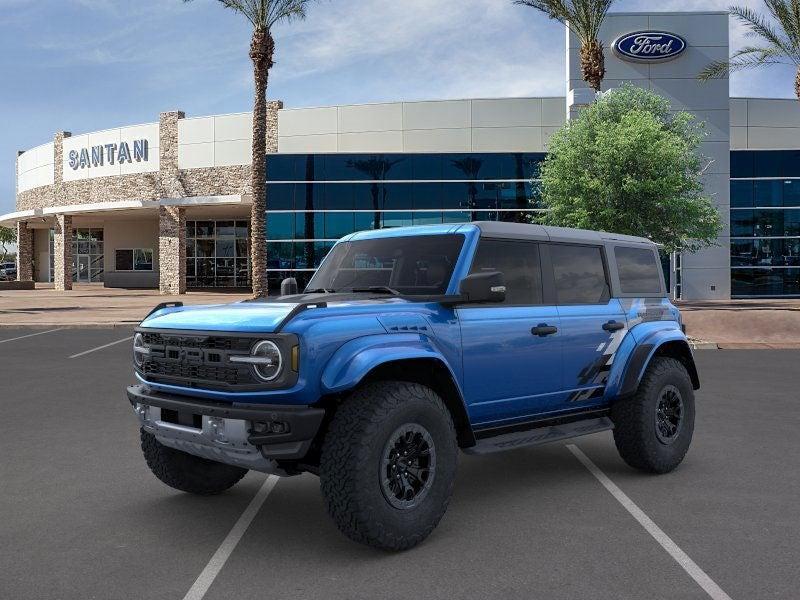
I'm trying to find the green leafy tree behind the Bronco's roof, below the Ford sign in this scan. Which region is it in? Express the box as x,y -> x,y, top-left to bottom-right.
537,85 -> 722,252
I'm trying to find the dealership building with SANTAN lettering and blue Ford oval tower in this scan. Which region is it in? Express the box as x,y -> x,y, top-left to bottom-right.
0,12 -> 800,300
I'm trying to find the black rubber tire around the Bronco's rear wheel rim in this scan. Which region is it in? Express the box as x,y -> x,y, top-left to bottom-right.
611,356 -> 695,473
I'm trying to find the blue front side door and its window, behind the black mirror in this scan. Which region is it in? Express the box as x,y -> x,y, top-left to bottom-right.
458,239 -> 562,425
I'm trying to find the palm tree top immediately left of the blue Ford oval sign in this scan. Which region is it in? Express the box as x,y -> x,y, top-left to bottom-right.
514,0 -> 614,92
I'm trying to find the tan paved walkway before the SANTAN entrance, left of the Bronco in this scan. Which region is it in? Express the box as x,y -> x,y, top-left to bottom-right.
0,284 -> 250,328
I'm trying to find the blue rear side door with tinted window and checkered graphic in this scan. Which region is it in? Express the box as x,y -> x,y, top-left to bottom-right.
543,243 -> 626,409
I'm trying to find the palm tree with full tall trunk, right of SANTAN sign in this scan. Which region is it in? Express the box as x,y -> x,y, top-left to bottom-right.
183,0 -> 313,298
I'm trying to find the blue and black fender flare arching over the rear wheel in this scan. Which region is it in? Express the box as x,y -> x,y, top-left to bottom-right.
614,329 -> 700,397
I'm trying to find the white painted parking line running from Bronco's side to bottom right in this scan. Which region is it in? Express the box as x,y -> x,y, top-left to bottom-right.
567,444 -> 731,600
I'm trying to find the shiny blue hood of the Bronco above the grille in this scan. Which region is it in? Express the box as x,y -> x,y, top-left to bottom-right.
141,302 -> 297,333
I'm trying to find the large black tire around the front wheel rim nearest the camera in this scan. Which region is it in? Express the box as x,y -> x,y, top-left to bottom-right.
320,381 -> 458,551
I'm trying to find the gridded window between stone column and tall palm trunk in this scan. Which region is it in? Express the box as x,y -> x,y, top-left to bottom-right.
186,220 -> 251,288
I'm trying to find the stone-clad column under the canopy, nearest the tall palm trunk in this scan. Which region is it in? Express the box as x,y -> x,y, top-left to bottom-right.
158,206 -> 186,295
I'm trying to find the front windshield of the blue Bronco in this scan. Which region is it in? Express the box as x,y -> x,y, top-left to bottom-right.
306,234 -> 464,295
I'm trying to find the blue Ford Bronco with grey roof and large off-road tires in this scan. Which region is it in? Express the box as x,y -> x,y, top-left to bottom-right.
127,223 -> 699,550
